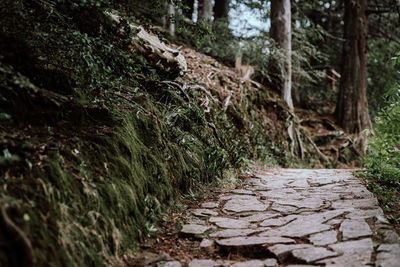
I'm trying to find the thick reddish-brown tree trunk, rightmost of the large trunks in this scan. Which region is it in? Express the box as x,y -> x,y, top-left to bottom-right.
335,0 -> 371,133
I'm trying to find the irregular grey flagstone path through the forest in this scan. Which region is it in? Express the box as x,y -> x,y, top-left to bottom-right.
135,169 -> 400,267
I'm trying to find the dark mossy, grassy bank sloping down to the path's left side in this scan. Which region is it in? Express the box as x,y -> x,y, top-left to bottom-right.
0,0 -> 288,266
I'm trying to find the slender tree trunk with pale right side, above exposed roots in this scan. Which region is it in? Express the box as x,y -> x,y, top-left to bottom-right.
270,0 -> 293,110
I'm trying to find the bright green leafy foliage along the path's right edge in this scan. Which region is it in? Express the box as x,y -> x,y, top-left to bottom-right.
360,53 -> 400,218
